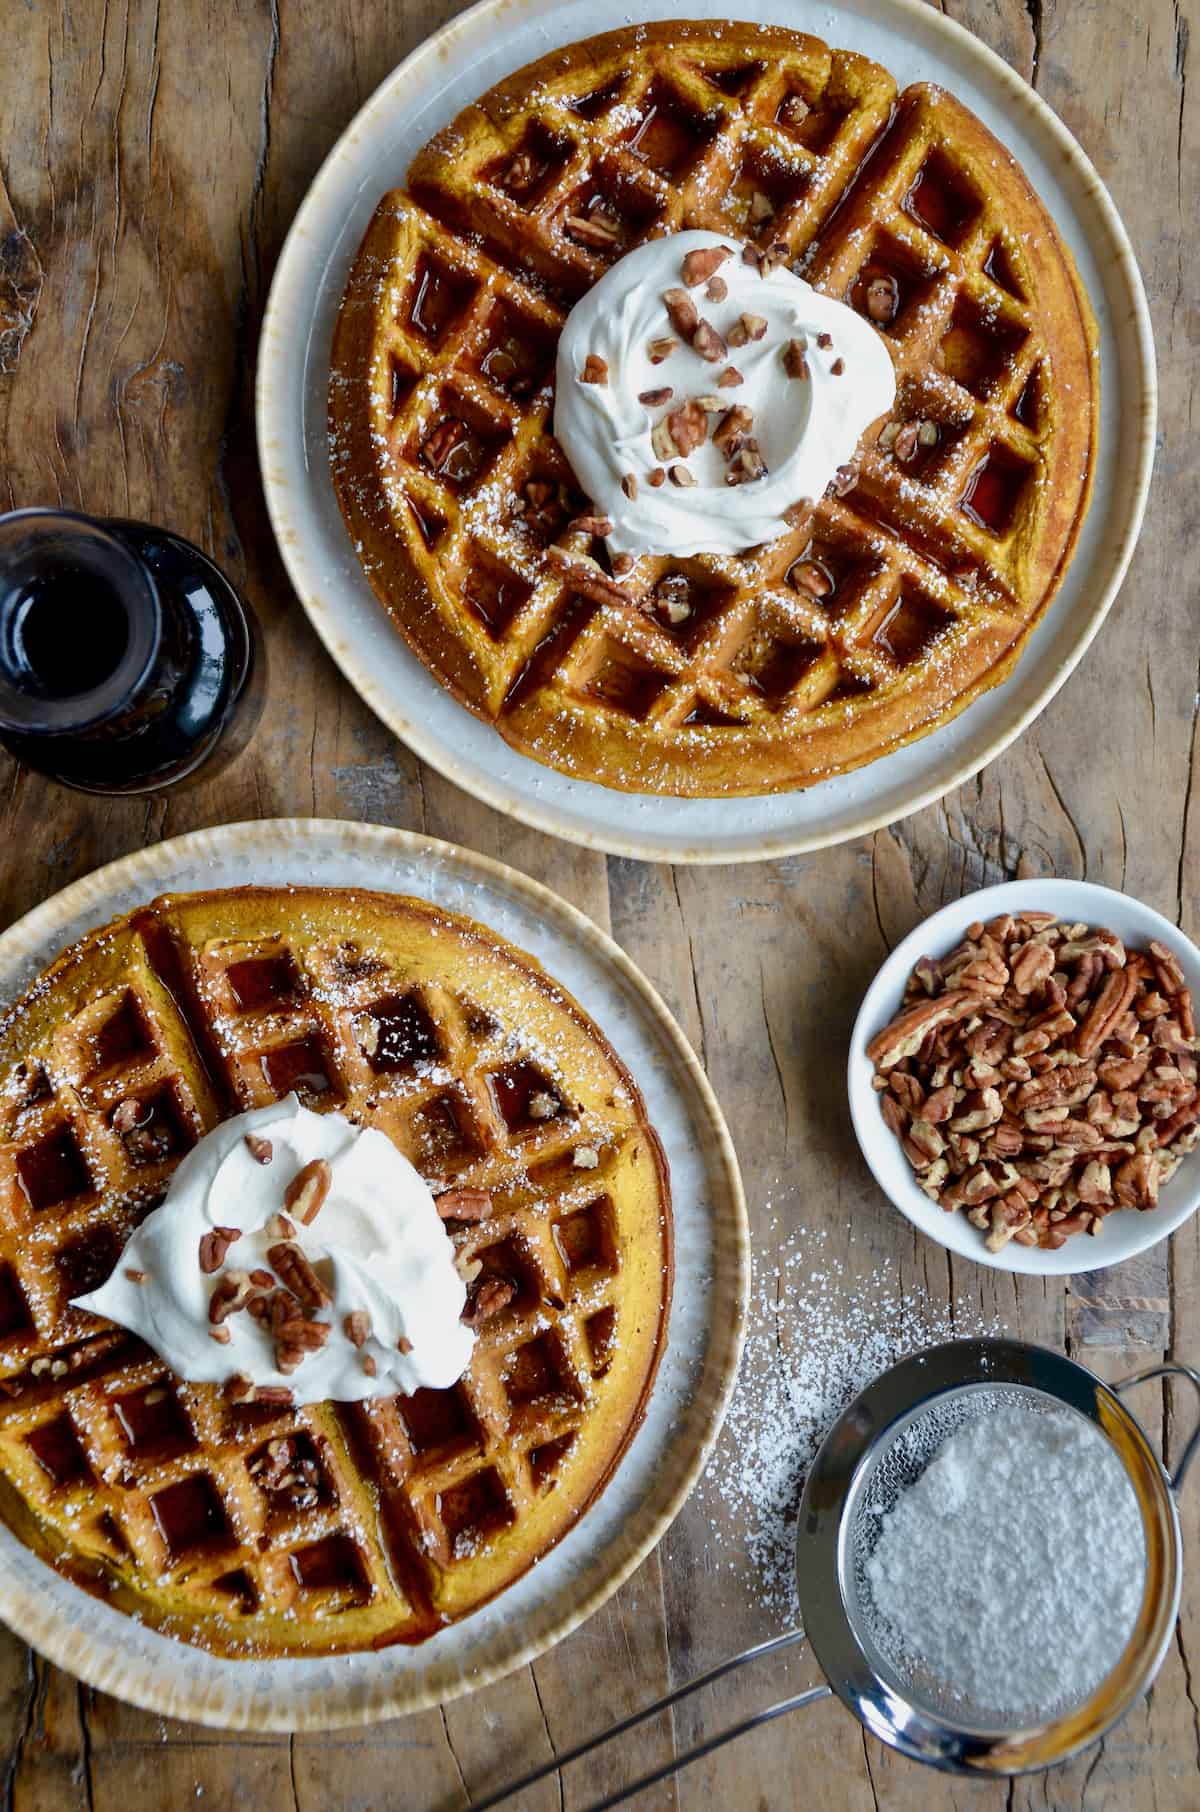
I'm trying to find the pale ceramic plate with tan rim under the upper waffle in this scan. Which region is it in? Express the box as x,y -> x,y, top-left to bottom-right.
257,0 -> 1155,863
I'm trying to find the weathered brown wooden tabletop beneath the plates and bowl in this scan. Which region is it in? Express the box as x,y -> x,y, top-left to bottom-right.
0,0 -> 1200,1812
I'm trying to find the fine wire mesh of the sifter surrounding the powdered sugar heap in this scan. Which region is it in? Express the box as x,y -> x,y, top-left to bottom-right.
839,1384 -> 1144,1736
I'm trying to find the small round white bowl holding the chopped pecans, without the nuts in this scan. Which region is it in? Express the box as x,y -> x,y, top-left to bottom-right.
848,881 -> 1200,1277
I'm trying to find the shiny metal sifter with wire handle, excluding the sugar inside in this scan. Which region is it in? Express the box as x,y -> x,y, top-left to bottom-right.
473,1339 -> 1200,1812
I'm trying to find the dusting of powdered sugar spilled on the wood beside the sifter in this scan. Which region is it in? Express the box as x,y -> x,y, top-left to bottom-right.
707,1227 -> 1004,1624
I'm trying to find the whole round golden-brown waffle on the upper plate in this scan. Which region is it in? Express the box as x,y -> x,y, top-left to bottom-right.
330,24 -> 1098,795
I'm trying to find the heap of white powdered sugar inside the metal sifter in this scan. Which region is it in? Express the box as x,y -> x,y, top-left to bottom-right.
865,1402 -> 1146,1723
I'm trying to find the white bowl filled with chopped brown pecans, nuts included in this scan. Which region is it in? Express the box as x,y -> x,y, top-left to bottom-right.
848,881 -> 1200,1276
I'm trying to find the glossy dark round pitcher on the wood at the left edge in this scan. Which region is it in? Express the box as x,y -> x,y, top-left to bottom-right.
0,509 -> 265,794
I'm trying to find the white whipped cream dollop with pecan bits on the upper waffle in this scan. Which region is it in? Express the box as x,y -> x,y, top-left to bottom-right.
555,232 -> 895,556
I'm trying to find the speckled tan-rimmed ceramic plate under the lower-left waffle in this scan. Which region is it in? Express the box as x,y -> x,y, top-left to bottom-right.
0,819 -> 749,1730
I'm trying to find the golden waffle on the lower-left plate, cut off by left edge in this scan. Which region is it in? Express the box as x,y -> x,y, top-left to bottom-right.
0,890 -> 671,1656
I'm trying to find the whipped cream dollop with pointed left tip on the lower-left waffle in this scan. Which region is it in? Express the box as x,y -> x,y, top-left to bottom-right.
76,1094 -> 475,1402
